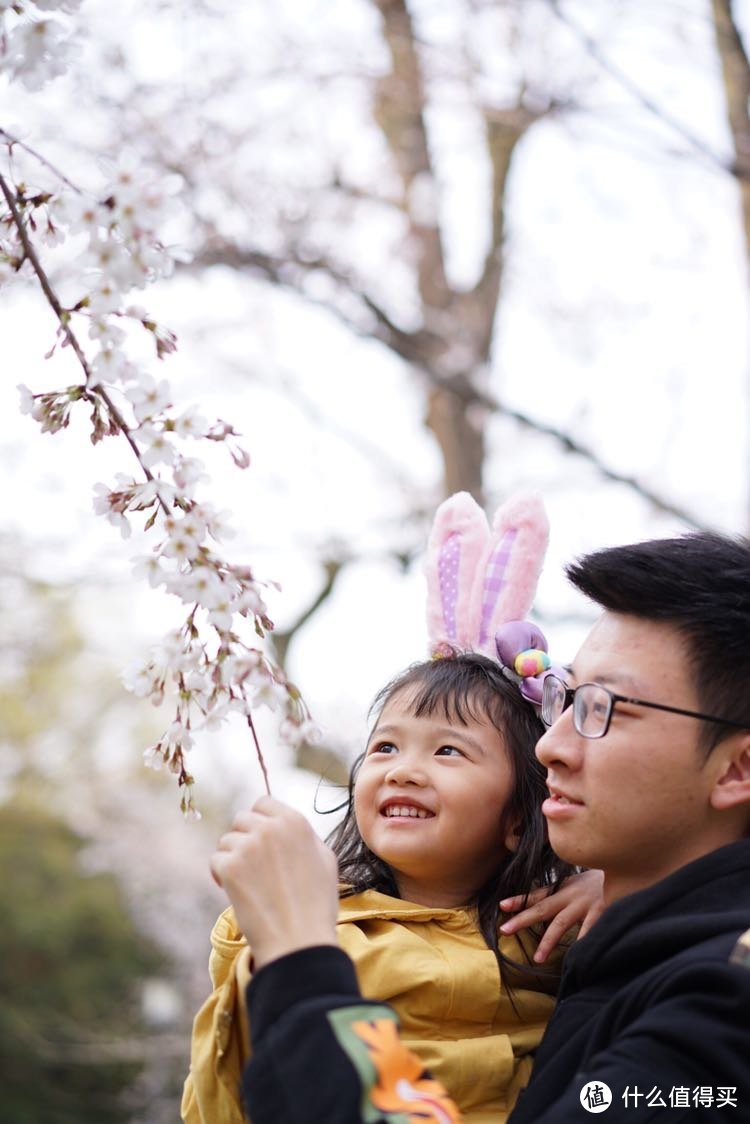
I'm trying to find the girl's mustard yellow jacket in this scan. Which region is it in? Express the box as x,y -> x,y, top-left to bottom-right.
182,890 -> 562,1124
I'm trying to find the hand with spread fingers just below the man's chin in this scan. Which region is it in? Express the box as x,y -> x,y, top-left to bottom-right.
500,870 -> 604,964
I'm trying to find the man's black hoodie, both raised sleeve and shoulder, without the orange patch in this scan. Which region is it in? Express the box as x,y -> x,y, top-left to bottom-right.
244,840 -> 750,1124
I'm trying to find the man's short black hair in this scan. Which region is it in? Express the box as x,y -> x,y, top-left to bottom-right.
566,532 -> 750,752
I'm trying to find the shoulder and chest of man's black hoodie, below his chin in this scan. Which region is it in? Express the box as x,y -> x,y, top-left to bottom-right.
510,841 -> 750,1124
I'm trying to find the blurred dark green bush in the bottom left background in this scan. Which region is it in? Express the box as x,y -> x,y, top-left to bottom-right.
0,805 -> 165,1124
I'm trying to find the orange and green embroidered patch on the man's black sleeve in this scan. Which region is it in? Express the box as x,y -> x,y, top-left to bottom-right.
328,1006 -> 461,1124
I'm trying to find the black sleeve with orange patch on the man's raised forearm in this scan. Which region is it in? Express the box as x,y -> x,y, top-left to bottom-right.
243,945 -> 459,1124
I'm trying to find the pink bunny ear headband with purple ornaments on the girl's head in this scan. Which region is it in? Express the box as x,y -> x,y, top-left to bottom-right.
426,492 -> 551,705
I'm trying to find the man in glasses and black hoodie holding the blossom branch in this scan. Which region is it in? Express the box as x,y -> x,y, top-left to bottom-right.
213,534 -> 750,1124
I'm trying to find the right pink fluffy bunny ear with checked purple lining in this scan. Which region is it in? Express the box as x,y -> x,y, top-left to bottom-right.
469,495 -> 550,659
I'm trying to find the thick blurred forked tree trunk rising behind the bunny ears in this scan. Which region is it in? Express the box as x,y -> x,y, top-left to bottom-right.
373,0 -> 541,504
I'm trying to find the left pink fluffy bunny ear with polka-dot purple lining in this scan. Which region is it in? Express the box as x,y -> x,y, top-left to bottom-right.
426,492 -> 490,655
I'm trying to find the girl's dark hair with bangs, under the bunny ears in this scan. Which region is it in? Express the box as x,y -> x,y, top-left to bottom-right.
326,652 -> 575,986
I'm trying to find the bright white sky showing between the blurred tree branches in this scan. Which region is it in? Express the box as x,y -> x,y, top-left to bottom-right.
0,0 -> 749,810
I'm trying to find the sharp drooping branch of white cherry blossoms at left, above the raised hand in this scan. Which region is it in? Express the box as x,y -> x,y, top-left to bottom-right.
0,133 -> 319,816
